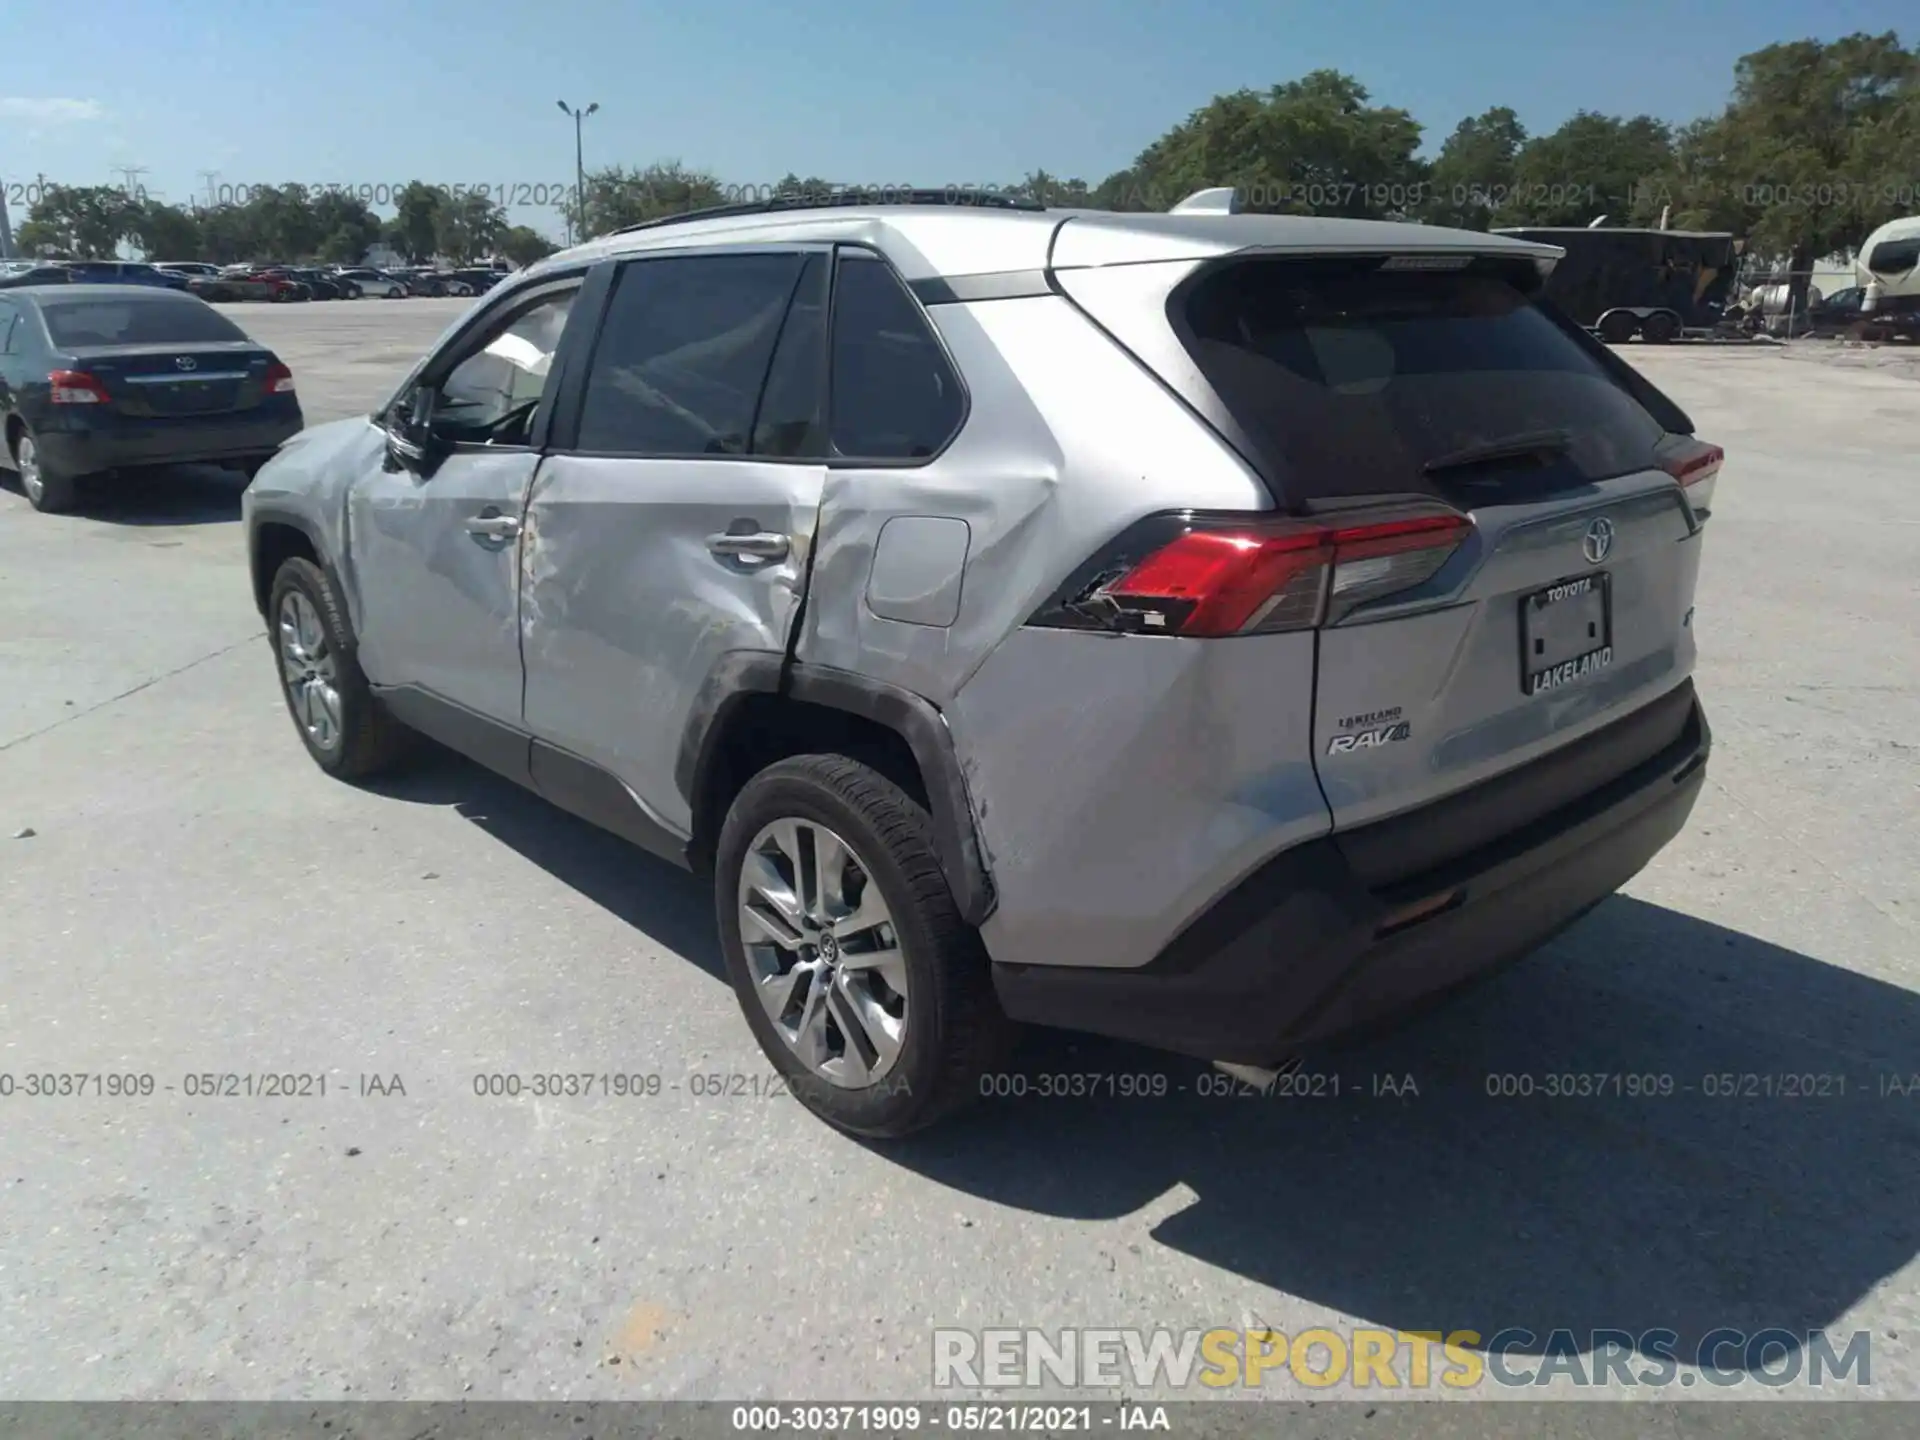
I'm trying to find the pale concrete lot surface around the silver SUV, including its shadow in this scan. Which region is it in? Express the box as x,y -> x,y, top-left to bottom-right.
0,300 -> 1920,1432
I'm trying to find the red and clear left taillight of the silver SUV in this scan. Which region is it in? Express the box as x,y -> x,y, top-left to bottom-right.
1033,507 -> 1473,637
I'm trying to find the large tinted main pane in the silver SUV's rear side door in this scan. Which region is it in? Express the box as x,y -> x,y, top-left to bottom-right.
578,253 -> 803,455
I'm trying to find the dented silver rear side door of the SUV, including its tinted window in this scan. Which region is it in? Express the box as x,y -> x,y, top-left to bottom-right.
520,248 -> 828,835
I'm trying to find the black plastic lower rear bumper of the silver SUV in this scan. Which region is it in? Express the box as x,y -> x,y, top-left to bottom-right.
993,691 -> 1711,1064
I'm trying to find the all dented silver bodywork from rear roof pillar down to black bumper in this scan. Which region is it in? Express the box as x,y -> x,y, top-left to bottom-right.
799,296 -> 1305,966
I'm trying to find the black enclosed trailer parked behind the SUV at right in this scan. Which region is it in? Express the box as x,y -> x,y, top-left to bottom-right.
1496,227 -> 1745,346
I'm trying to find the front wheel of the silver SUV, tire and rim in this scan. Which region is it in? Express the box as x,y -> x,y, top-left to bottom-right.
267,557 -> 413,780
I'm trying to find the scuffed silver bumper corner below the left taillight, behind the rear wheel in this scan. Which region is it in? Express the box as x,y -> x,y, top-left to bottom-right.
952,630 -> 1332,966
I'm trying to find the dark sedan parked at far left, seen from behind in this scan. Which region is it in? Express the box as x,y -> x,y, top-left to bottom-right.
0,284 -> 303,511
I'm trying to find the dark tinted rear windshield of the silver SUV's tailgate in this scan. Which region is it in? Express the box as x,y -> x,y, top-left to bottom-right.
1175,259 -> 1665,505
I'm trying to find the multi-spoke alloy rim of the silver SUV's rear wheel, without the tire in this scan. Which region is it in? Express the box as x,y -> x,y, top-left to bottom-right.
737,818 -> 908,1089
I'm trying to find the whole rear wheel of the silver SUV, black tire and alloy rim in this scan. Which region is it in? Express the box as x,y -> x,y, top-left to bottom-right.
714,755 -> 1010,1139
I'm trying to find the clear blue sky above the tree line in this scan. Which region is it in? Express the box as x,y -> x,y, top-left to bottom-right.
0,0 -> 1920,234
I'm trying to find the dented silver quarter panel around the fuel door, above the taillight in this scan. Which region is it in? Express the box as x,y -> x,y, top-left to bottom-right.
799,296 -> 1271,708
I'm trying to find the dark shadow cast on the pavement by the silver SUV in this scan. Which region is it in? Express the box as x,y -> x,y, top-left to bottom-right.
362,756 -> 1920,1365
